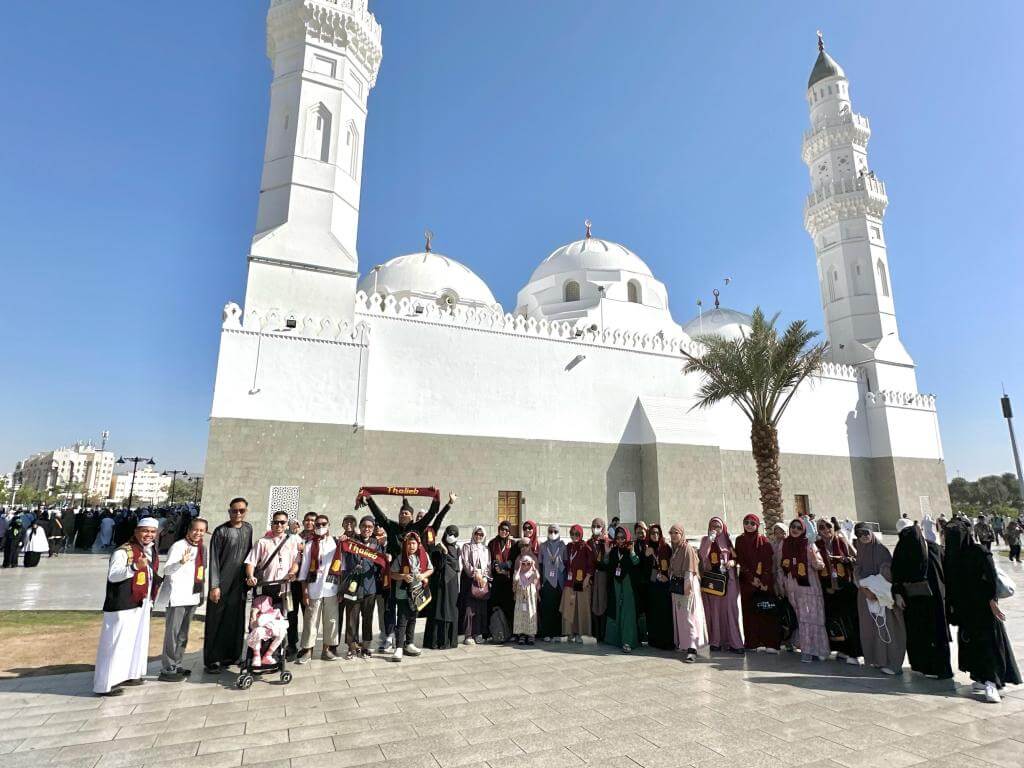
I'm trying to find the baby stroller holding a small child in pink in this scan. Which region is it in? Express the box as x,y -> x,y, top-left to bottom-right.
234,582 -> 292,690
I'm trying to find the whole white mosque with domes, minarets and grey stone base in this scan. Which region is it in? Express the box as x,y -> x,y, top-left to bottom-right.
203,0 -> 949,532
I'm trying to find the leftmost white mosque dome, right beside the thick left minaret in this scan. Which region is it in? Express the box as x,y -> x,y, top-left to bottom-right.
358,251 -> 498,306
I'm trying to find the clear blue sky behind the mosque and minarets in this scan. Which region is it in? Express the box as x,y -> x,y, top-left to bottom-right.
0,0 -> 1024,477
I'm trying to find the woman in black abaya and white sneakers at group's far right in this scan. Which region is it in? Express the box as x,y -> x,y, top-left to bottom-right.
942,520 -> 1021,703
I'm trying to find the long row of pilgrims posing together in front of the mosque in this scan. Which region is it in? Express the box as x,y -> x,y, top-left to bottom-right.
95,492 -> 1021,701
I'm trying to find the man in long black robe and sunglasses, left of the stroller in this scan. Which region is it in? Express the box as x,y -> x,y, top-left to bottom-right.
203,497 -> 253,674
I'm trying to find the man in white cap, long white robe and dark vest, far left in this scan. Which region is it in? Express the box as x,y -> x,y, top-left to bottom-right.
92,517 -> 160,696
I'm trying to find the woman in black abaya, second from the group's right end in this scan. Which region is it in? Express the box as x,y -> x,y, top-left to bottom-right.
892,523 -> 953,680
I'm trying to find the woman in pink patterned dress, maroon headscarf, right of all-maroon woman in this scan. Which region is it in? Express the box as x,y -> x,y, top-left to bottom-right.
782,517 -> 830,662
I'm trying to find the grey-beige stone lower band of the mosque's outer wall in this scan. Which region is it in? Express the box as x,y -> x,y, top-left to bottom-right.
203,418 -> 950,536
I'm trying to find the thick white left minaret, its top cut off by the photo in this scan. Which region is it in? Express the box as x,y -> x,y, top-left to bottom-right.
246,0 -> 382,327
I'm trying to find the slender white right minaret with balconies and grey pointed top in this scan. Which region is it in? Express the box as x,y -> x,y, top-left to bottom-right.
803,33 -> 918,392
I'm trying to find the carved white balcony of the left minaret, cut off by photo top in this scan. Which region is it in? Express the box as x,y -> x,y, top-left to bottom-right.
266,0 -> 383,87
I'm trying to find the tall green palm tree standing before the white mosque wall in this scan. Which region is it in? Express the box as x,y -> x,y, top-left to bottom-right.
683,307 -> 828,526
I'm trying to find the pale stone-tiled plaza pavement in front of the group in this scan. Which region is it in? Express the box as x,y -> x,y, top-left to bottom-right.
0,556 -> 1024,768
